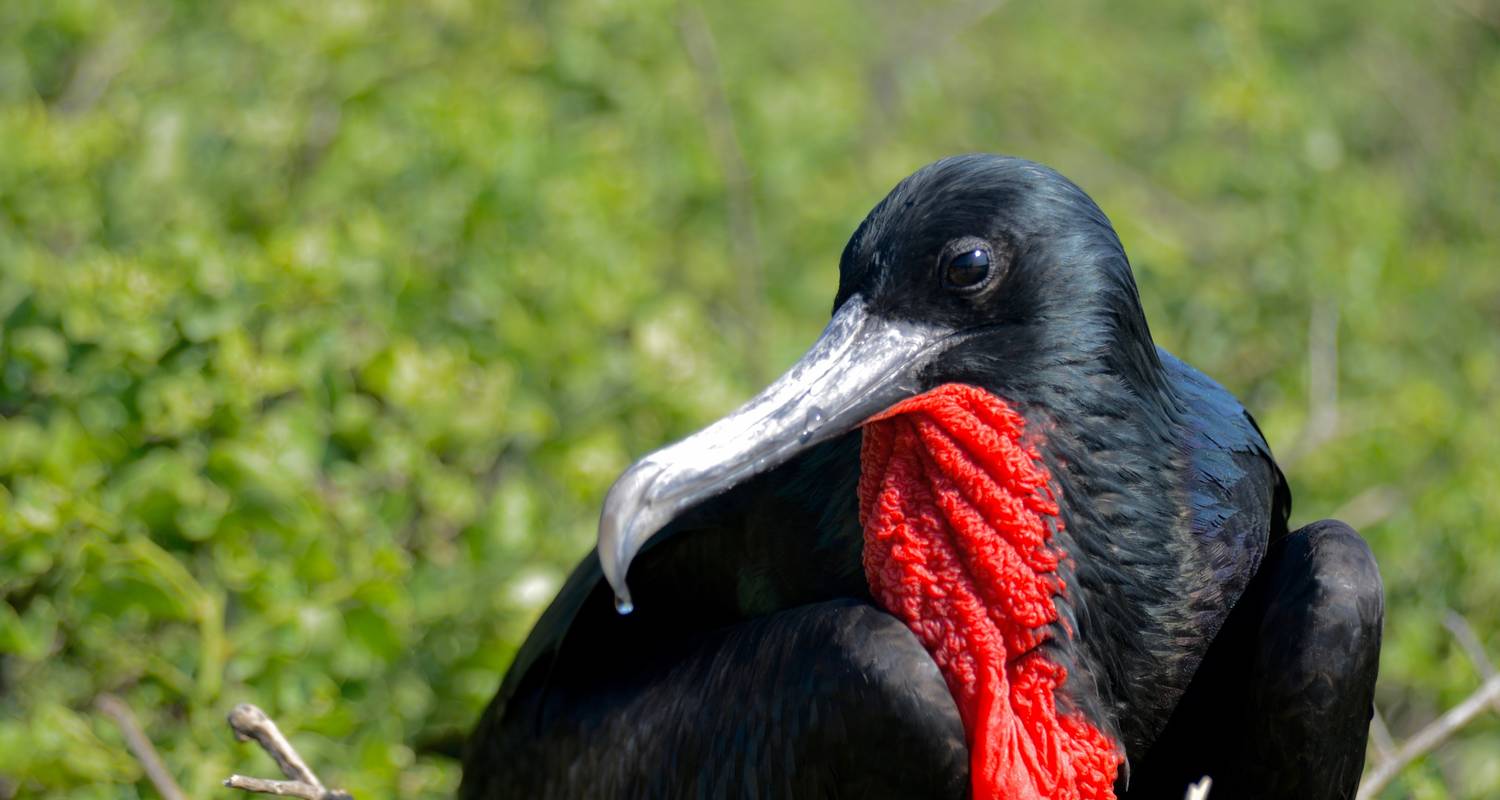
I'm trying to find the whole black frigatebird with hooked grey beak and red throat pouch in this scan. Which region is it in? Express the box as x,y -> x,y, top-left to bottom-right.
461,155 -> 1383,800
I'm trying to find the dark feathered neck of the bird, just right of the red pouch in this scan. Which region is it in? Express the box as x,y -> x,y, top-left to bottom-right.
1005,365 -> 1214,758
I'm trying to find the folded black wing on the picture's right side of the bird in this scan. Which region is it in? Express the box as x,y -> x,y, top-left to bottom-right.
1127,519 -> 1385,800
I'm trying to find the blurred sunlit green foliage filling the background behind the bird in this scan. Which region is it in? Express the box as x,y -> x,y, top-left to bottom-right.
0,0 -> 1500,798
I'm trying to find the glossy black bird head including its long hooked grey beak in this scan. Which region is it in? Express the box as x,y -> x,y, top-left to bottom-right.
599,155 -> 1160,611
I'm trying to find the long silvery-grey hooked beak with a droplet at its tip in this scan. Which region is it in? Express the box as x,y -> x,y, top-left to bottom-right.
599,296 -> 948,614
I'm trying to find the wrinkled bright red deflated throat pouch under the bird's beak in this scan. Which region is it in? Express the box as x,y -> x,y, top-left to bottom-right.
860,384 -> 1124,800
